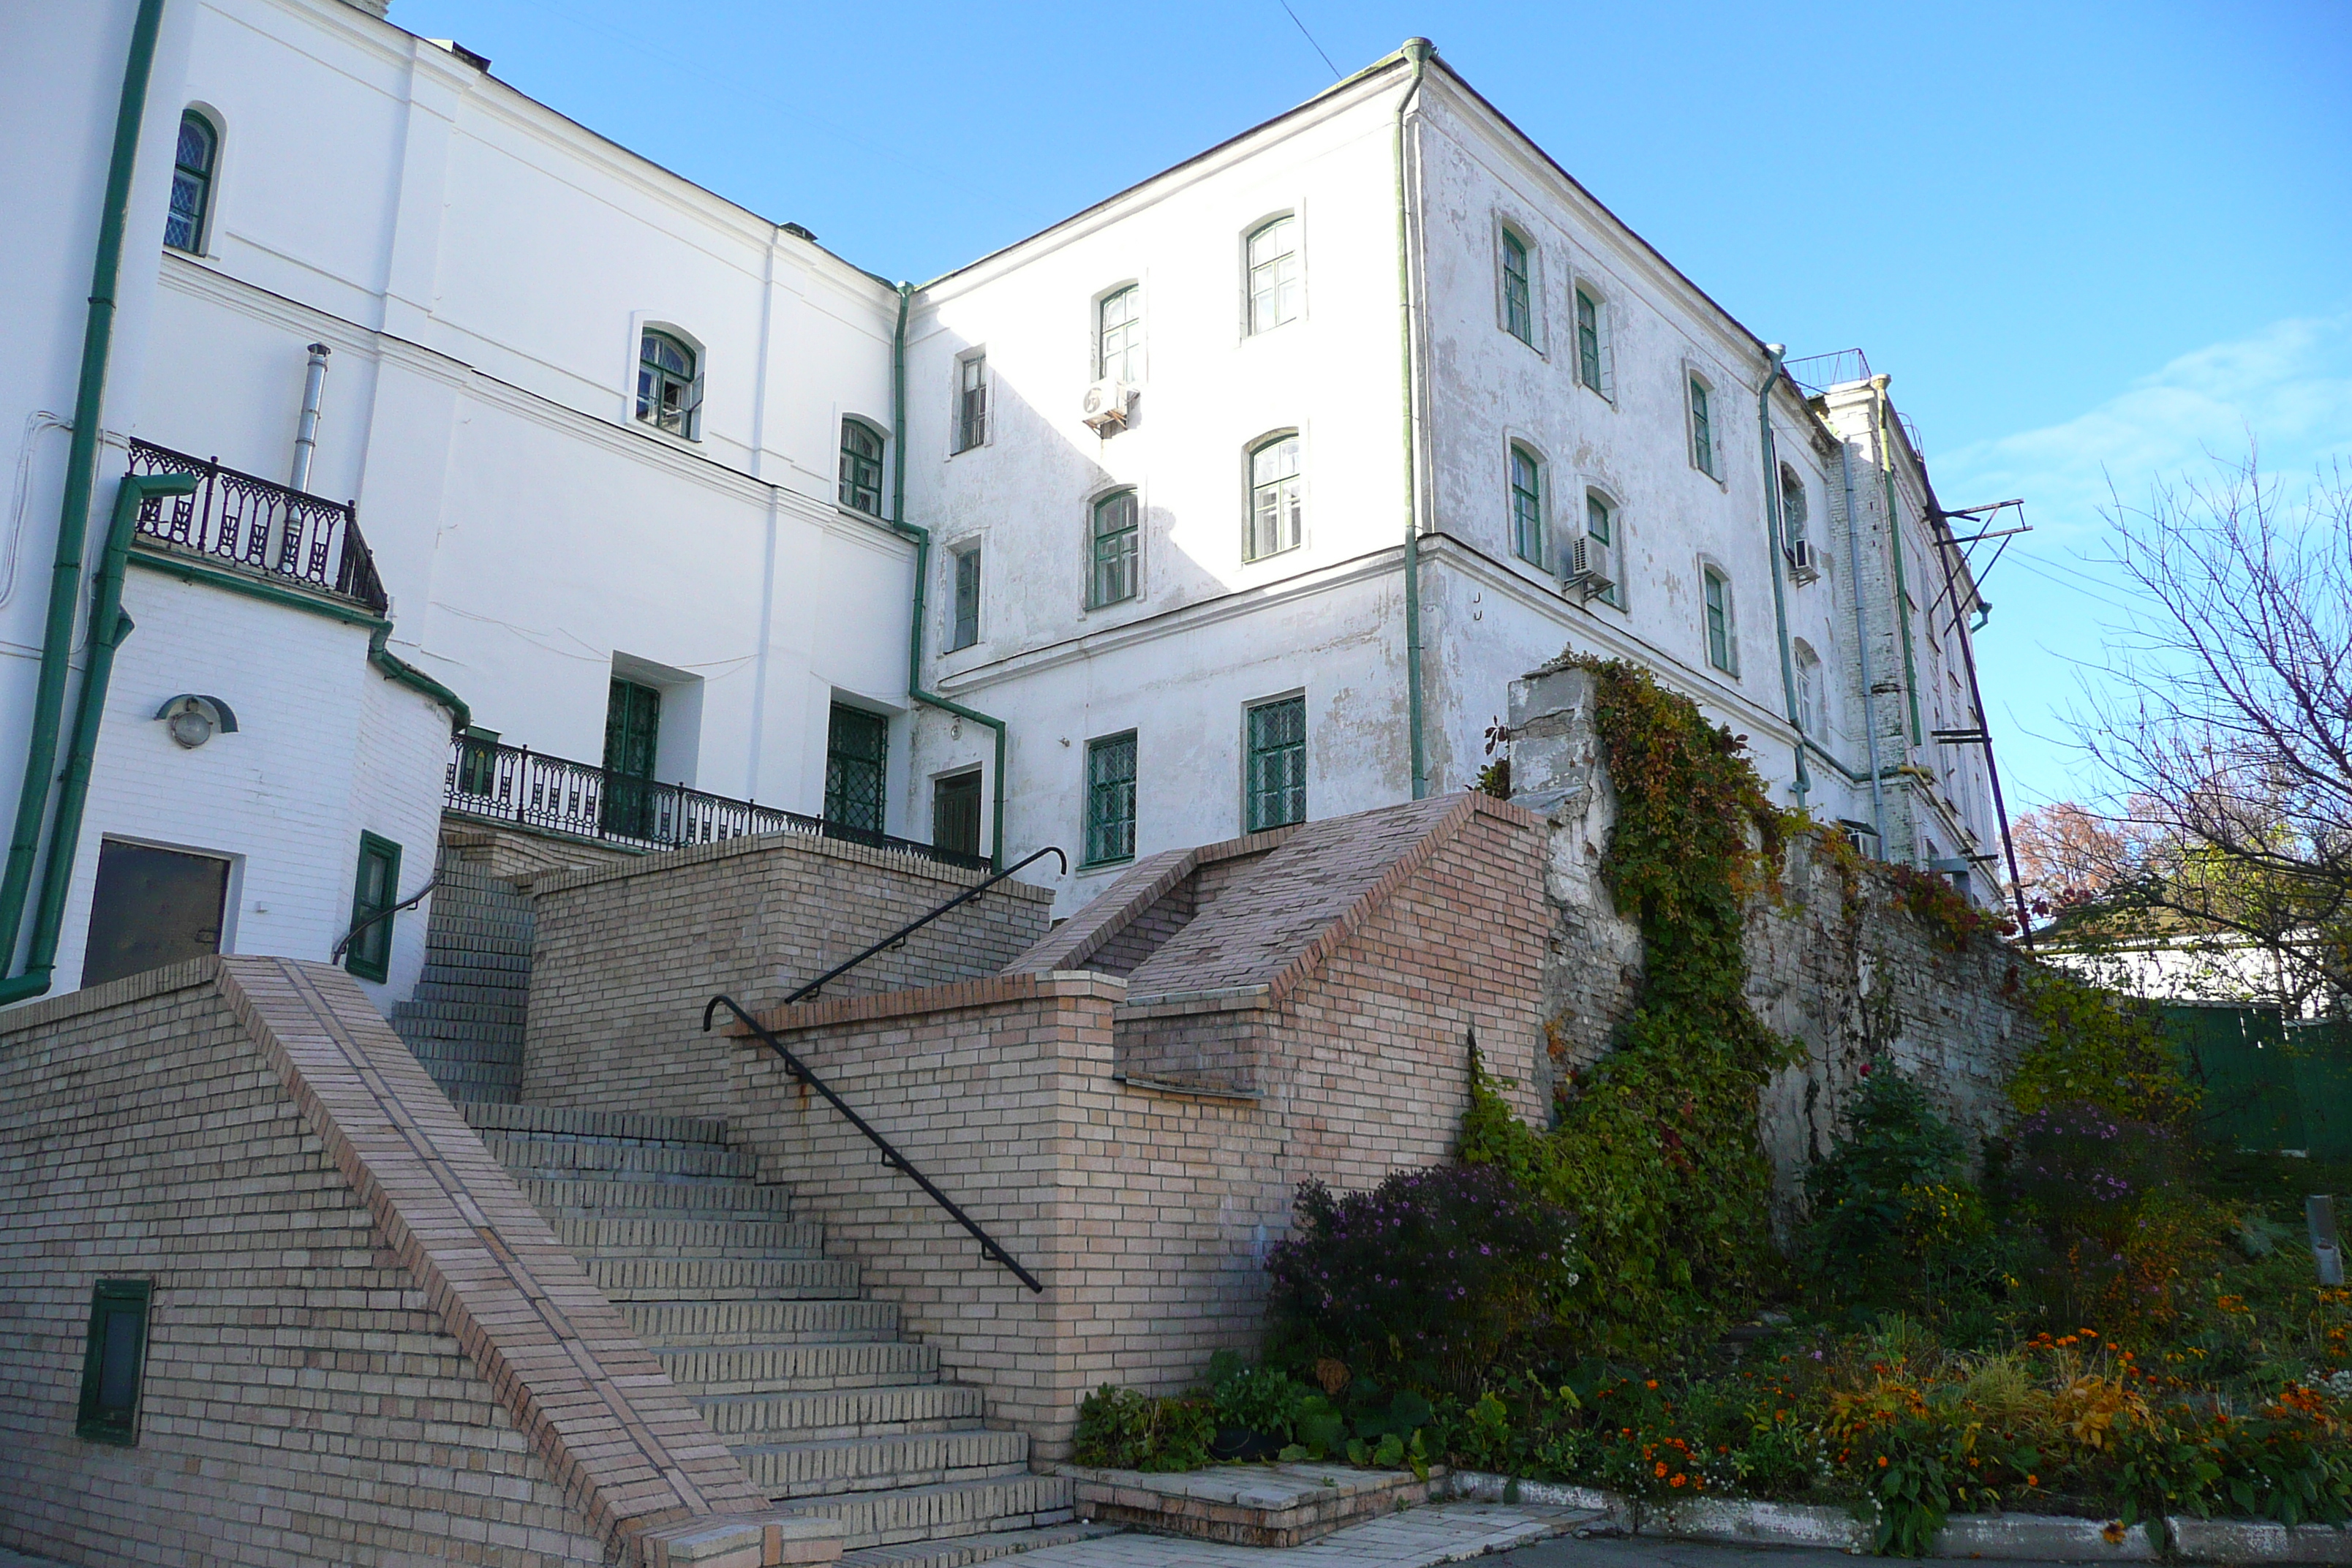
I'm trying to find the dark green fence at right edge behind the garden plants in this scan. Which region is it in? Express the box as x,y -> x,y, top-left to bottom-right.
2159,1004 -> 2352,1159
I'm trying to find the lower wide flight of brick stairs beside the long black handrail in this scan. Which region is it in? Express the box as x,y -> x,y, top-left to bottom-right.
459,1104 -> 1098,1568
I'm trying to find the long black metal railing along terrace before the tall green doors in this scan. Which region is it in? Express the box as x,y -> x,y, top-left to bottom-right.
447,736 -> 992,870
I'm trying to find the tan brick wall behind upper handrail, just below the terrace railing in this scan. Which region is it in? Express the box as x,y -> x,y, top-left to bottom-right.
522,832 -> 1054,1117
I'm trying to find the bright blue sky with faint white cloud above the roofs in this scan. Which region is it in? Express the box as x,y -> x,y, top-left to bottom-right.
391,0 -> 2352,811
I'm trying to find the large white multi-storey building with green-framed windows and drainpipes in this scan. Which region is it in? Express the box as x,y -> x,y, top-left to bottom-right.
0,0 -> 1997,1001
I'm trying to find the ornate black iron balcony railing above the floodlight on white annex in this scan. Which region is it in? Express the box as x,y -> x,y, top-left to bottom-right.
132,442 -> 391,616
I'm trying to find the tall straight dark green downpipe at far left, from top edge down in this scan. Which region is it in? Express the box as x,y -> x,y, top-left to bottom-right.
0,0 -> 162,997
